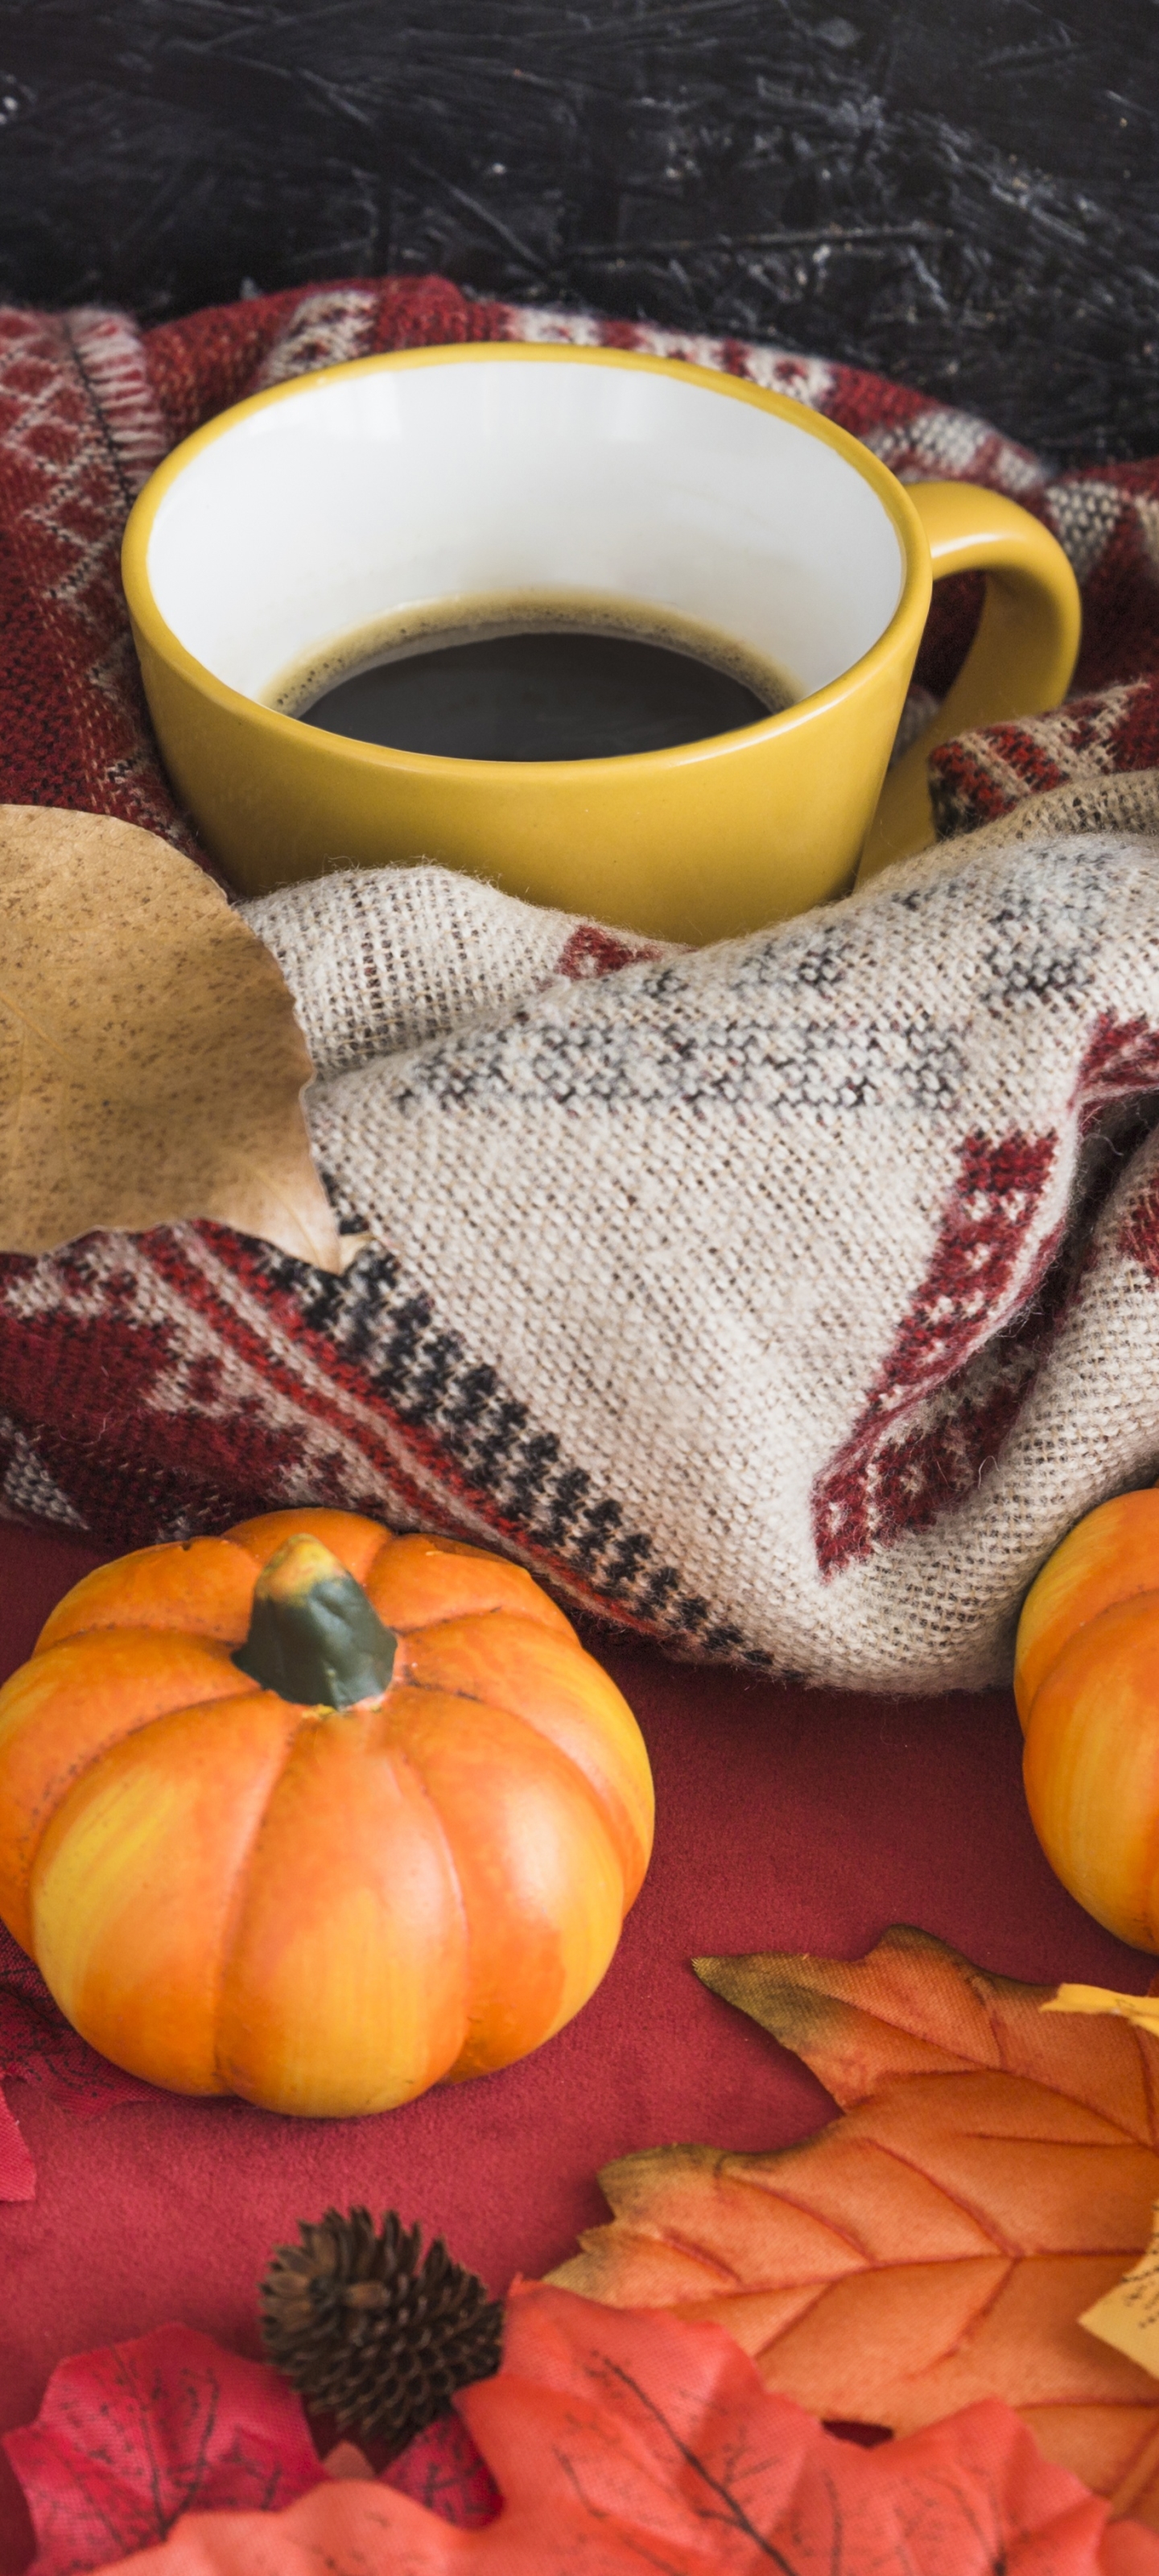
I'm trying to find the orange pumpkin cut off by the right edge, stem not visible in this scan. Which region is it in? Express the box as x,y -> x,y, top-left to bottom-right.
1015,1486 -> 1159,1950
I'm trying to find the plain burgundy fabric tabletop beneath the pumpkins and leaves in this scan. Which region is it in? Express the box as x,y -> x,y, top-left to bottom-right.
0,1528 -> 1154,2576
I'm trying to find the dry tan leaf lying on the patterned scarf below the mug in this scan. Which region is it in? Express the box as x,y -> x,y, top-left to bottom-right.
0,807 -> 343,1270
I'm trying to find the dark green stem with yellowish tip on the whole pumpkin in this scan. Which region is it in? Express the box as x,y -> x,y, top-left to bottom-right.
232,1535 -> 399,1708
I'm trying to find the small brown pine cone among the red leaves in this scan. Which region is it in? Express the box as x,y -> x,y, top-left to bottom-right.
262,2211 -> 502,2452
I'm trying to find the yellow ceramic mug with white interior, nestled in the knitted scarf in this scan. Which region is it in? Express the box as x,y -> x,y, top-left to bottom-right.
124,343 -> 1079,943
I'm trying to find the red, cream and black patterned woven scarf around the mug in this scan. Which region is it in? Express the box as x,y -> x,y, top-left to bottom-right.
0,279 -> 1159,1690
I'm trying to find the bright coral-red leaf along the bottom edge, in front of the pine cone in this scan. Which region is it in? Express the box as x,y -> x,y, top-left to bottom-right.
50,2285 -> 1159,2576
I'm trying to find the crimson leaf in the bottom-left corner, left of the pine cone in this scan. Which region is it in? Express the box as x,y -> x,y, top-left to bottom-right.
5,2326 -> 324,2576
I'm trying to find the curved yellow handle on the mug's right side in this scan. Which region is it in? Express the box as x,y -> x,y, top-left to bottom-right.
855,485 -> 1082,886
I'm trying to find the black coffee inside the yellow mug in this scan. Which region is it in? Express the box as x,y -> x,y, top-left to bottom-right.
301,631 -> 770,760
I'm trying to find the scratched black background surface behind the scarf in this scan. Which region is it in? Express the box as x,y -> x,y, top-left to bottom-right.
0,0 -> 1159,459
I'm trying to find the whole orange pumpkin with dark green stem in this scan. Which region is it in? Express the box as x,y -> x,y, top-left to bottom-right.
0,1509 -> 652,2112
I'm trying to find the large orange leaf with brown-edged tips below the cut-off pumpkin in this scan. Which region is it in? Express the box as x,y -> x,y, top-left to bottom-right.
554,1930 -> 1159,2529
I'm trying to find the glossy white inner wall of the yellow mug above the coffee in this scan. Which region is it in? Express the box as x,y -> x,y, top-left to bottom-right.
146,350 -> 904,721
